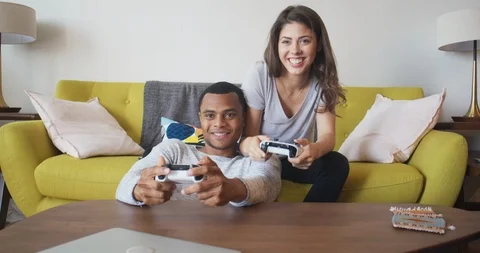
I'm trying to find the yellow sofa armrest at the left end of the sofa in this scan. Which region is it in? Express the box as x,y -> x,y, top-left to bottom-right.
0,120 -> 59,217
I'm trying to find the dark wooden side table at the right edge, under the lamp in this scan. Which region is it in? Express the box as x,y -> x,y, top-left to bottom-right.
434,122 -> 480,211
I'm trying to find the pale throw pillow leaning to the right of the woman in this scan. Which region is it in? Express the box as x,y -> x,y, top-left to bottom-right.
338,89 -> 446,163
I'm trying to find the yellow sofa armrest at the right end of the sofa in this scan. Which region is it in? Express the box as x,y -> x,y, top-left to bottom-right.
408,130 -> 468,206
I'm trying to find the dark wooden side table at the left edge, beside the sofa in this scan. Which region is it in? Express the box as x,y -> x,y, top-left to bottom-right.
0,113 -> 40,229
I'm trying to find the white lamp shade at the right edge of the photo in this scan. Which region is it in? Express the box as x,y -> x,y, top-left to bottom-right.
437,9 -> 480,51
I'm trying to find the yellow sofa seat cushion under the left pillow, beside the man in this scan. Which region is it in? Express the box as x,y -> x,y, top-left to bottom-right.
35,155 -> 138,200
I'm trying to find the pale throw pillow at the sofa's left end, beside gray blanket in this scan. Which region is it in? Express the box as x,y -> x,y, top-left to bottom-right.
25,91 -> 144,159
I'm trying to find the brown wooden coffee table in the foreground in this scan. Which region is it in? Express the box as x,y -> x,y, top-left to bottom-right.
0,200 -> 480,253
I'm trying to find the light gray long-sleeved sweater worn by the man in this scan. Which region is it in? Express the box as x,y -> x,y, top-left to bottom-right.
116,139 -> 281,206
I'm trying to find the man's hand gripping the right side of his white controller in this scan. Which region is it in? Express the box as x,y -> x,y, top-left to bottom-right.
182,156 -> 247,206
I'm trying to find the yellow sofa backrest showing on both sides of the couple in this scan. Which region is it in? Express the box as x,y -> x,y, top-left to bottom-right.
55,80 -> 424,150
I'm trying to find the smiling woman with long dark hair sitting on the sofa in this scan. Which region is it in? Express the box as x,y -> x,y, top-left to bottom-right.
240,5 -> 350,202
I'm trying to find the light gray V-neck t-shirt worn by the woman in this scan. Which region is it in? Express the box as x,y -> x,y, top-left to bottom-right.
242,62 -> 324,143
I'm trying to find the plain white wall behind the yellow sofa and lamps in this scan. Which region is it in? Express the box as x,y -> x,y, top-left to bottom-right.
2,0 -> 480,121
